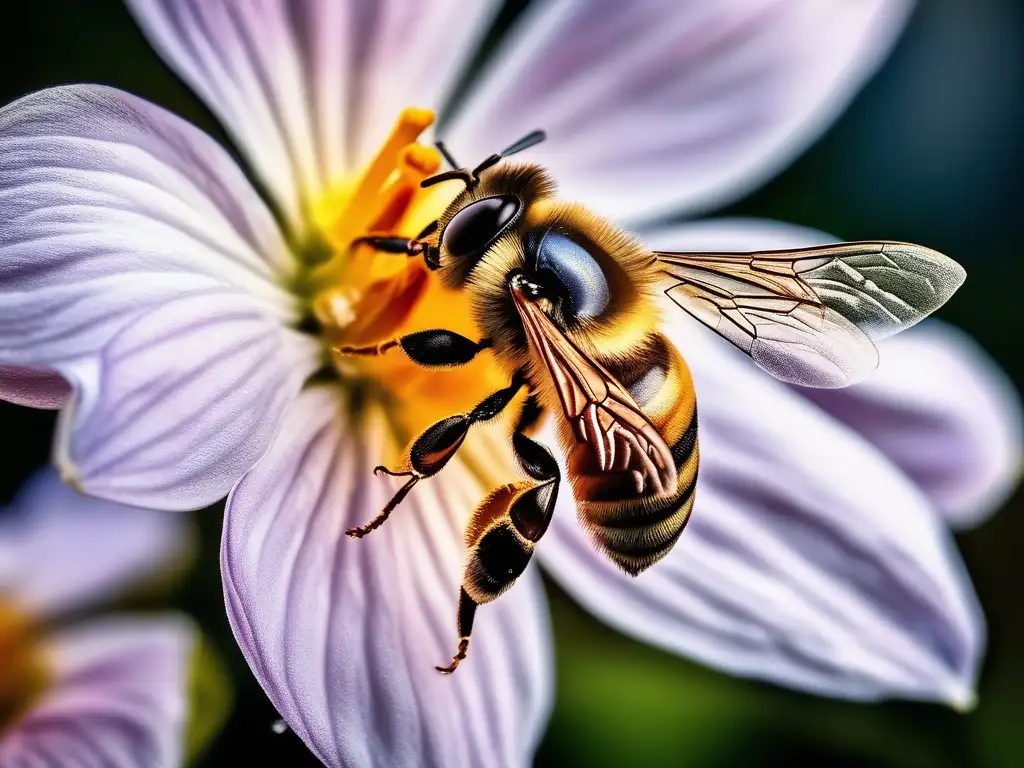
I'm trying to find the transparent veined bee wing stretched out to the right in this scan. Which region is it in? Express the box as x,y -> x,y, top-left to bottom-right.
656,242 -> 966,387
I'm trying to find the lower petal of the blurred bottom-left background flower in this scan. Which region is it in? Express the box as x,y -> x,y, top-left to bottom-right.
0,616 -> 196,768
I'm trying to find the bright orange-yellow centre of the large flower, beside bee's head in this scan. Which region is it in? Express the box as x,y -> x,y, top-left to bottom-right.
303,109 -> 508,454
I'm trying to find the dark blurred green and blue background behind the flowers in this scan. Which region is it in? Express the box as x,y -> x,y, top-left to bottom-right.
0,0 -> 1024,768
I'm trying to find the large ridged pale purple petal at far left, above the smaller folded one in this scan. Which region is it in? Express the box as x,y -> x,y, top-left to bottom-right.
0,85 -> 298,404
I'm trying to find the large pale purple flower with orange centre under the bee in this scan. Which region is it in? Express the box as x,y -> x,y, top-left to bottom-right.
0,0 -> 1020,766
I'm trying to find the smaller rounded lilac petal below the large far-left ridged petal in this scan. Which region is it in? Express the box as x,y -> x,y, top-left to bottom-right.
56,291 -> 319,509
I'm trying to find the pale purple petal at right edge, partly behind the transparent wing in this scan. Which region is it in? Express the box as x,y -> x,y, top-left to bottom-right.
647,219 -> 1022,524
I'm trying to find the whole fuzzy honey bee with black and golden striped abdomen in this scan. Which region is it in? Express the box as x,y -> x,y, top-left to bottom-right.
338,131 -> 965,674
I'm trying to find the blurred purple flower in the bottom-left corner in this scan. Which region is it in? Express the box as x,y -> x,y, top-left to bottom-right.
0,471 -> 197,768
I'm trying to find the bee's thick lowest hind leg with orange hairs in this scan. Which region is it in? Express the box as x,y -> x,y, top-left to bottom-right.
436,432 -> 561,675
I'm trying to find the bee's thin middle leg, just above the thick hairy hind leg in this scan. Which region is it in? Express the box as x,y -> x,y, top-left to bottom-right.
345,374 -> 526,539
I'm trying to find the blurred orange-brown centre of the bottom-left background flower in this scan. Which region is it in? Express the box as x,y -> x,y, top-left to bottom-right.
0,599 -> 50,734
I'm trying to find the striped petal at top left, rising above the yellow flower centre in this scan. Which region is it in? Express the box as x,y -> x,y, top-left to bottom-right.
128,0 -> 496,232
